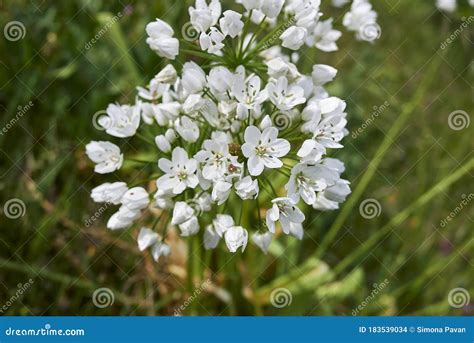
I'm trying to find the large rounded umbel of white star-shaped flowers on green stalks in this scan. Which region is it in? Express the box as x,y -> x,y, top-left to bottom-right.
86,0 -> 376,260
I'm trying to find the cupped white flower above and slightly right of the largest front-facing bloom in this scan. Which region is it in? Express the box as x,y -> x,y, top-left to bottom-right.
267,76 -> 306,111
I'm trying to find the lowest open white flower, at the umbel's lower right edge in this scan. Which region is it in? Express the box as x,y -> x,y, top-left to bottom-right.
266,198 -> 305,234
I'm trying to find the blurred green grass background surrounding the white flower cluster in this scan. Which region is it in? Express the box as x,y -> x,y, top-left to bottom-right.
0,0 -> 474,315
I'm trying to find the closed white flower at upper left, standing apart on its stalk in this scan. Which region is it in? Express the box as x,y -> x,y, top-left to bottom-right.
146,19 -> 179,60
